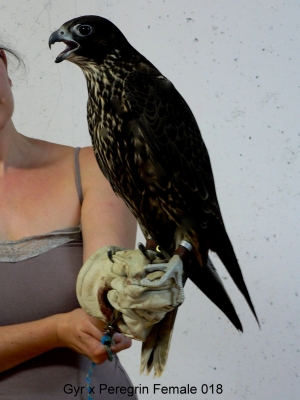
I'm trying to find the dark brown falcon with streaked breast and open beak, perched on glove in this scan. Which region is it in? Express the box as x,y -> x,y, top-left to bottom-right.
49,15 -> 258,342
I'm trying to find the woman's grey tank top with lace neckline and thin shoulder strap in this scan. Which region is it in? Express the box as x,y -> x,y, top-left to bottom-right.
0,148 -> 137,400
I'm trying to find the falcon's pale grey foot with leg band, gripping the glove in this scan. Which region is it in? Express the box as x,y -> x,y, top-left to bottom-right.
140,241 -> 192,303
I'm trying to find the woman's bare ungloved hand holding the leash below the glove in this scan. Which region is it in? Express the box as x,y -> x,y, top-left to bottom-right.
54,308 -> 131,364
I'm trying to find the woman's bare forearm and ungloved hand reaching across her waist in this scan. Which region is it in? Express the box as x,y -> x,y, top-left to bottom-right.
0,308 -> 131,372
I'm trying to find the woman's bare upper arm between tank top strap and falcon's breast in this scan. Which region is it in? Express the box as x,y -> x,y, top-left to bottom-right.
79,147 -> 137,261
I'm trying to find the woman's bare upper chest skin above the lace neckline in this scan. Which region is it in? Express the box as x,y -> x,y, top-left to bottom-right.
0,163 -> 80,240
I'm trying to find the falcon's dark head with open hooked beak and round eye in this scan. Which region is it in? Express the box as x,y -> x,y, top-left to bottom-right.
49,15 -> 130,64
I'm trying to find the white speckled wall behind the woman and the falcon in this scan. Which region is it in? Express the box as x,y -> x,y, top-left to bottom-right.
0,0 -> 300,400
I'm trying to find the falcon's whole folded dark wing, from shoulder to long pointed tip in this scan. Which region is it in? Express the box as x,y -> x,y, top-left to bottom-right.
123,69 -> 257,319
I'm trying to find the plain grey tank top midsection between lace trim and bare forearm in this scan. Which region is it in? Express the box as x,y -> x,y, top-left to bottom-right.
0,241 -> 82,325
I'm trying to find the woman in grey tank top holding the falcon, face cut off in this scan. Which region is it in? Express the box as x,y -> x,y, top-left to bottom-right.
0,48 -> 136,400
